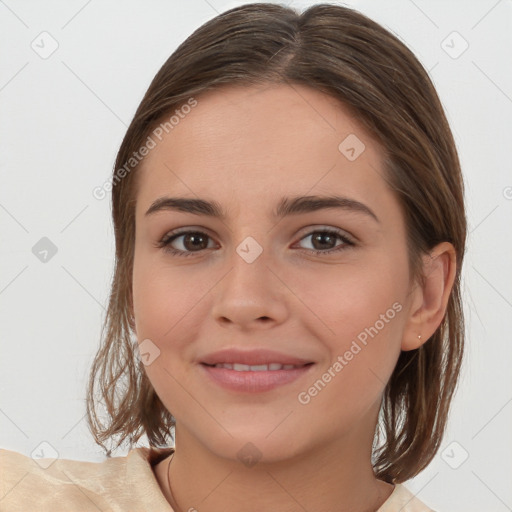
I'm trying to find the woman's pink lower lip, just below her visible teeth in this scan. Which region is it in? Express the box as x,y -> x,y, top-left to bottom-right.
200,364 -> 314,393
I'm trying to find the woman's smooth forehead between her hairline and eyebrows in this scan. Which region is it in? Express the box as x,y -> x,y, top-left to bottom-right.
137,84 -> 386,216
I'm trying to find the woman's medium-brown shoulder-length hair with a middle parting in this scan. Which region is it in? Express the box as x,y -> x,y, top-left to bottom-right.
87,3 -> 466,483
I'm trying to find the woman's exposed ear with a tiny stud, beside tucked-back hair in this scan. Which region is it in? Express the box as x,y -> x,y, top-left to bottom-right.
402,242 -> 457,351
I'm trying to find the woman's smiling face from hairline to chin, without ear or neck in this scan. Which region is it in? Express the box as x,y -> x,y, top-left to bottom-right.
133,85 -> 414,461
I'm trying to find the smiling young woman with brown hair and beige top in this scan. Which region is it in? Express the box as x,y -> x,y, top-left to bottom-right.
0,4 -> 466,512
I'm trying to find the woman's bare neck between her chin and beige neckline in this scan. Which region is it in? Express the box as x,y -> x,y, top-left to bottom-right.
158,426 -> 393,512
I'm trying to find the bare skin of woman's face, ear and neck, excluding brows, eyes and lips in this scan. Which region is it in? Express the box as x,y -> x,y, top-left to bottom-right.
133,85 -> 455,512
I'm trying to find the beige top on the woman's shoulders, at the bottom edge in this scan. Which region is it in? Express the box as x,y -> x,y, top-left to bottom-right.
0,448 -> 434,512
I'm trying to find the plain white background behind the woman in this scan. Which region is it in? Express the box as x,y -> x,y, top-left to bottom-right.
0,0 -> 512,512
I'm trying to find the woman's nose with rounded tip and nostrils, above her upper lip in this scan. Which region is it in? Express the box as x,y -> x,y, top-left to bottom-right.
212,245 -> 290,330
